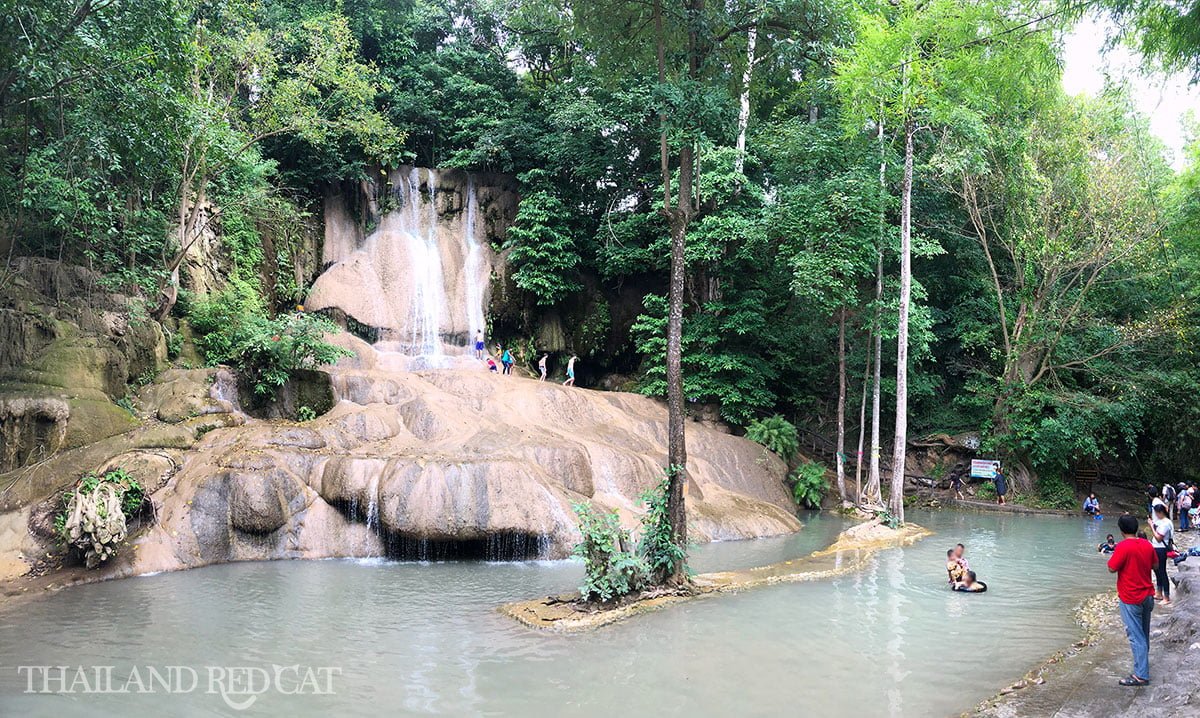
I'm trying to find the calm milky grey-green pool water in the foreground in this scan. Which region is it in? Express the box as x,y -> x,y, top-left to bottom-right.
0,513 -> 1115,718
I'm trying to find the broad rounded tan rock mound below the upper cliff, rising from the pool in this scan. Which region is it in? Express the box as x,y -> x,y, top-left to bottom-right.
117,335 -> 799,572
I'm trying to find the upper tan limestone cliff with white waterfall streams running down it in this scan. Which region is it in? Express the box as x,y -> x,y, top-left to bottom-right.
305,167 -> 516,366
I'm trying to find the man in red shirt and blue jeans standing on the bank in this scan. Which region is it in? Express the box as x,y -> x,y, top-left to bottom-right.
1109,514 -> 1158,686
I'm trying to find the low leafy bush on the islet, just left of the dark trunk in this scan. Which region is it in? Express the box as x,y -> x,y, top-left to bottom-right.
571,503 -> 649,603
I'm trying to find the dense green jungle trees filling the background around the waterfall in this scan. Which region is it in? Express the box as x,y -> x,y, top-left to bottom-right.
0,0 -> 1200,504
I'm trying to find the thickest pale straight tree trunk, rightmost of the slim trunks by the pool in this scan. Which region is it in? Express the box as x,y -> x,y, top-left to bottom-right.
888,116 -> 916,521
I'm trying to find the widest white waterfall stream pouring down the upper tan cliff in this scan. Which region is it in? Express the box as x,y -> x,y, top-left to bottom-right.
401,167 -> 446,357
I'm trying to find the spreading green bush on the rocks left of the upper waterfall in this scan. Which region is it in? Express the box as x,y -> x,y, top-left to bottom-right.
190,294 -> 350,399
